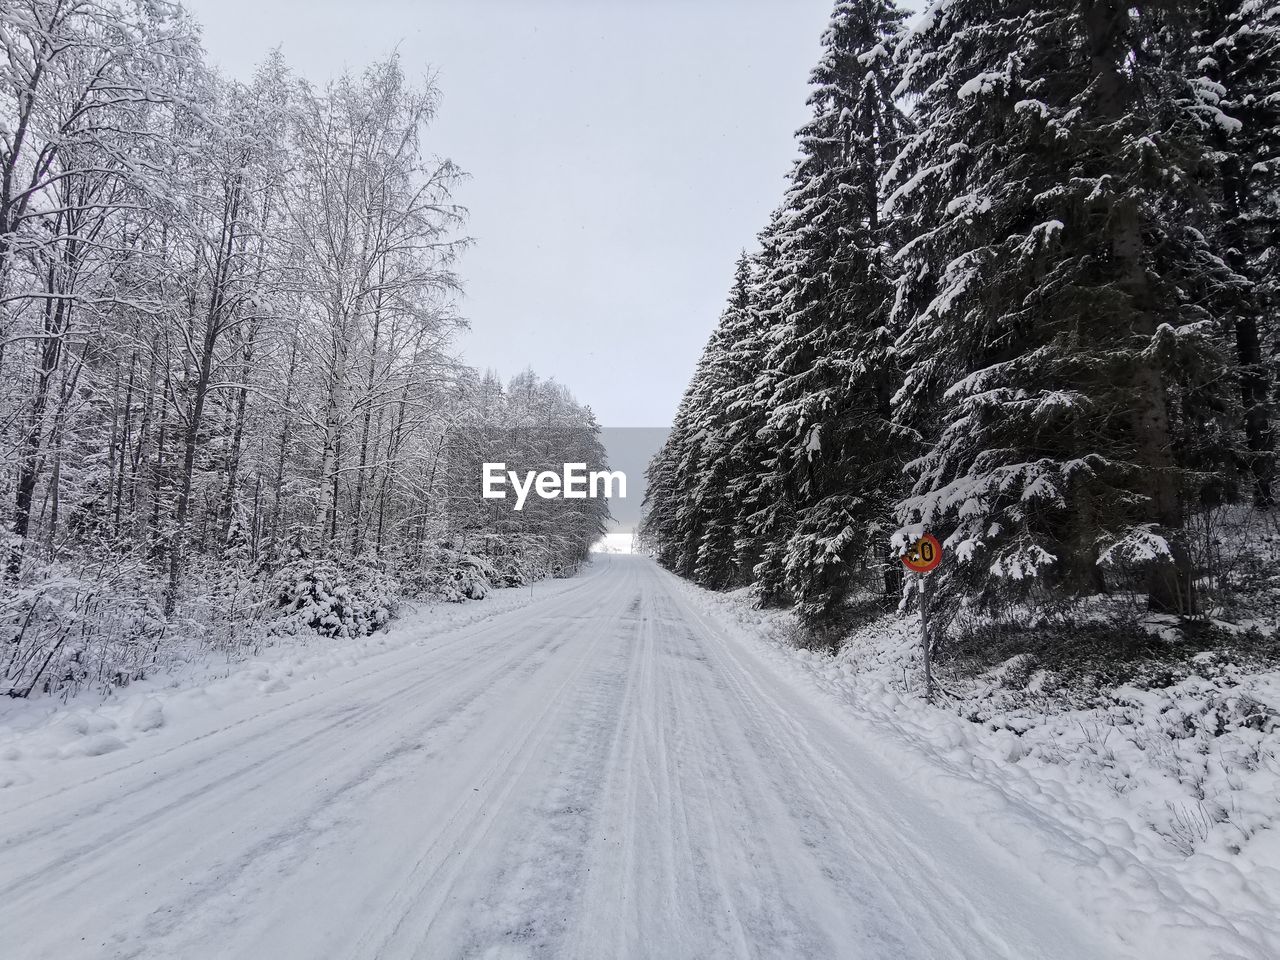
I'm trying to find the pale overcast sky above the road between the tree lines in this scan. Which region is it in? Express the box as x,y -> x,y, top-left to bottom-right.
186,0 -> 855,426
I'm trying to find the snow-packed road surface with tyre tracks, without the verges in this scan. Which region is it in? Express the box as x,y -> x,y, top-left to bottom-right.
0,557 -> 1112,960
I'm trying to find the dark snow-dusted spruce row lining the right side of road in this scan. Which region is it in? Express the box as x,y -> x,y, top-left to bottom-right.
644,0 -> 1280,634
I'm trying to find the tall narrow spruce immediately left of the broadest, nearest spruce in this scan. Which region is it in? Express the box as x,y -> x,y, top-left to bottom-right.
758,0 -> 906,625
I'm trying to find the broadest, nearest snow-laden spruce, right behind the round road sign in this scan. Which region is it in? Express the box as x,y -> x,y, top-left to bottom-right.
890,0 -> 1238,612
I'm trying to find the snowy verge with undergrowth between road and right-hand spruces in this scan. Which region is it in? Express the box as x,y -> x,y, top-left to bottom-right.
680,581 -> 1280,960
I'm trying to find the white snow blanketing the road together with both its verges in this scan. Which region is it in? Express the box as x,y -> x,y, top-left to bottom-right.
0,557 -> 1277,960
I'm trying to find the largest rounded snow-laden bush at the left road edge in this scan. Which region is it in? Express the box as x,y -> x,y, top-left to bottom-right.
264,549 -> 399,637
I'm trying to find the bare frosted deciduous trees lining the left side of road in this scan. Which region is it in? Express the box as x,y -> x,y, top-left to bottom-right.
0,0 -> 603,692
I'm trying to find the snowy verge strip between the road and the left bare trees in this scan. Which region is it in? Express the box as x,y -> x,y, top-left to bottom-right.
0,579 -> 582,788
